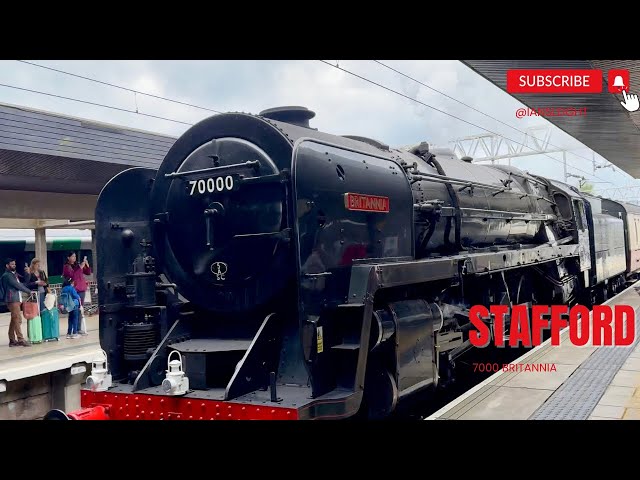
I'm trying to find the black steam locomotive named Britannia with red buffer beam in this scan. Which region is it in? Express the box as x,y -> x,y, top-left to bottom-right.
47,107 -> 640,420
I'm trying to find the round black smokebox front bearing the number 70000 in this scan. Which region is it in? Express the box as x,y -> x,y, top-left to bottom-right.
151,113 -> 300,313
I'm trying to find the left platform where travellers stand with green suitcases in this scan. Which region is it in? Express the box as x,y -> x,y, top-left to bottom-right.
0,313 -> 101,420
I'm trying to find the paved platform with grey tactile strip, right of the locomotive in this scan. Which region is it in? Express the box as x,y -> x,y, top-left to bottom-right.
425,282 -> 640,420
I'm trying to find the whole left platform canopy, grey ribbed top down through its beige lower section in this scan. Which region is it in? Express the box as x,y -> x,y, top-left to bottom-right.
0,103 -> 176,229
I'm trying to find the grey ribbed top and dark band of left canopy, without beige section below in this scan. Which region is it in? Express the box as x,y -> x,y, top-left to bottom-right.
0,103 -> 176,195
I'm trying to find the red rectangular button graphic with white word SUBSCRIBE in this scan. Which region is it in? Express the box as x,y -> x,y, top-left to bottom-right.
507,70 -> 602,93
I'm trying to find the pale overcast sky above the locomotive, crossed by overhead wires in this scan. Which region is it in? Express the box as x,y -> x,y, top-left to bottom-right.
0,60 -> 640,207
